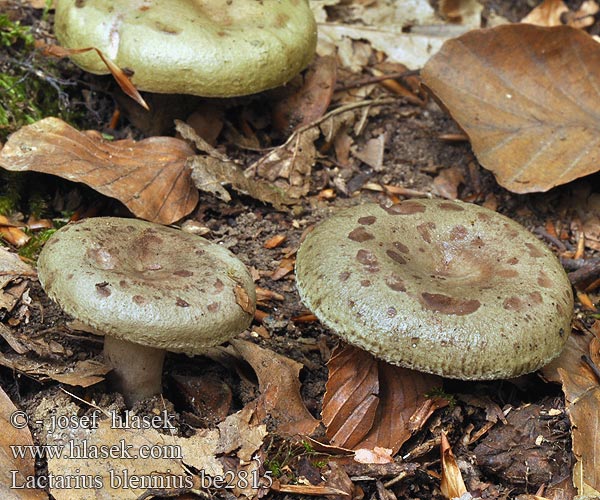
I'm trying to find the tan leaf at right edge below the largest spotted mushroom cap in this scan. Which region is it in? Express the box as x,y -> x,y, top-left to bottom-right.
558,362 -> 600,495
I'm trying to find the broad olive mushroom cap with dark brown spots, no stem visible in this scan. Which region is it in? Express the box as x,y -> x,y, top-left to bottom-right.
296,200 -> 573,379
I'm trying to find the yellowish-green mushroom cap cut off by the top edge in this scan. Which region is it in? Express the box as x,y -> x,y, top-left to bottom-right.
54,0 -> 317,97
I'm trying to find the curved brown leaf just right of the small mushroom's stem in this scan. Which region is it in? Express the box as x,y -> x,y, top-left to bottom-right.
231,339 -> 319,436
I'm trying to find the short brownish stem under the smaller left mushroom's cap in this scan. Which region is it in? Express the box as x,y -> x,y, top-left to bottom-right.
104,336 -> 166,407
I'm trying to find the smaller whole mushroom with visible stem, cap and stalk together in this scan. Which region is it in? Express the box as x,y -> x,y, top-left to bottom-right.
38,217 -> 256,405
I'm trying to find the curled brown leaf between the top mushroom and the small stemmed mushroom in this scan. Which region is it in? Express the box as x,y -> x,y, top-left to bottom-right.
0,118 -> 198,224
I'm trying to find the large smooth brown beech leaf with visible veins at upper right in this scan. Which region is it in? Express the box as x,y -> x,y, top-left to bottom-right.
422,24 -> 600,193
